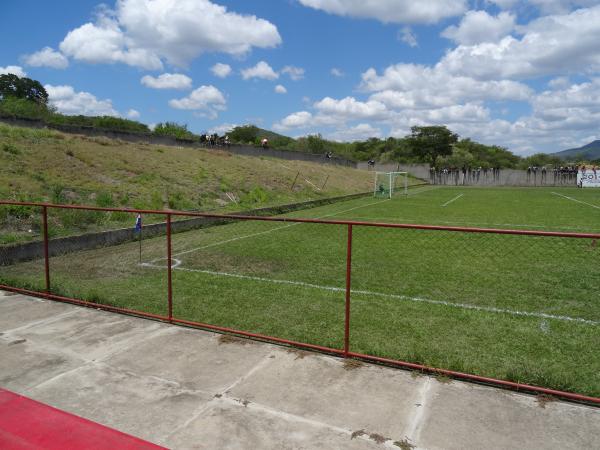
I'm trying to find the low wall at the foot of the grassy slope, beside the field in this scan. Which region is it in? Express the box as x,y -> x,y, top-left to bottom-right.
0,192 -> 371,266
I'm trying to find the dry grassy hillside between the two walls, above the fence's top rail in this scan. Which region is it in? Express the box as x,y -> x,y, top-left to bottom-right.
0,124 -> 382,243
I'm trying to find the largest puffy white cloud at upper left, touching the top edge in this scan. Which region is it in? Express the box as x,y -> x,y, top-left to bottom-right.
60,0 -> 281,70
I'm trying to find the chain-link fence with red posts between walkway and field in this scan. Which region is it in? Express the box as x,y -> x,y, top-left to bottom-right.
0,202 -> 600,401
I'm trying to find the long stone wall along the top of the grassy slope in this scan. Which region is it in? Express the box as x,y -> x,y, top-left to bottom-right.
0,117 -> 356,167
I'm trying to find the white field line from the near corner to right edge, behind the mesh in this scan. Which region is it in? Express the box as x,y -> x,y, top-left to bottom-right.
141,263 -> 600,325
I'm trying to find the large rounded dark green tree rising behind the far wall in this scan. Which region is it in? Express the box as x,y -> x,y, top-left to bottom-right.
407,126 -> 458,166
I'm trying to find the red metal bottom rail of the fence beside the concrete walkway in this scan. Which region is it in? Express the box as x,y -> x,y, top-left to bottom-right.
0,284 -> 600,406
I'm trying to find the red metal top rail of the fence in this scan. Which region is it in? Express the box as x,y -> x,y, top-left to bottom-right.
0,200 -> 600,239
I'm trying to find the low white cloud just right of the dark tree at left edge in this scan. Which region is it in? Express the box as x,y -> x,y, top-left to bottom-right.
44,84 -> 119,117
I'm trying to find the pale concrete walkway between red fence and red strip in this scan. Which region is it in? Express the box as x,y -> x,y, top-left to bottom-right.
0,292 -> 600,450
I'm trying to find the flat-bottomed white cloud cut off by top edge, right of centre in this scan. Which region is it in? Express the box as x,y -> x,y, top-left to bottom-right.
299,0 -> 467,23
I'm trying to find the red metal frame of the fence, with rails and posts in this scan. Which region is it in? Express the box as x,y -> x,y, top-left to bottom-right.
0,201 -> 600,405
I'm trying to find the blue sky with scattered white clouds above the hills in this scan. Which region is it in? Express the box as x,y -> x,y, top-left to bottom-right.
0,0 -> 600,154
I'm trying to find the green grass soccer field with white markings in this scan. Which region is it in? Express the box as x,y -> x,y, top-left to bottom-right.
0,186 -> 600,396
